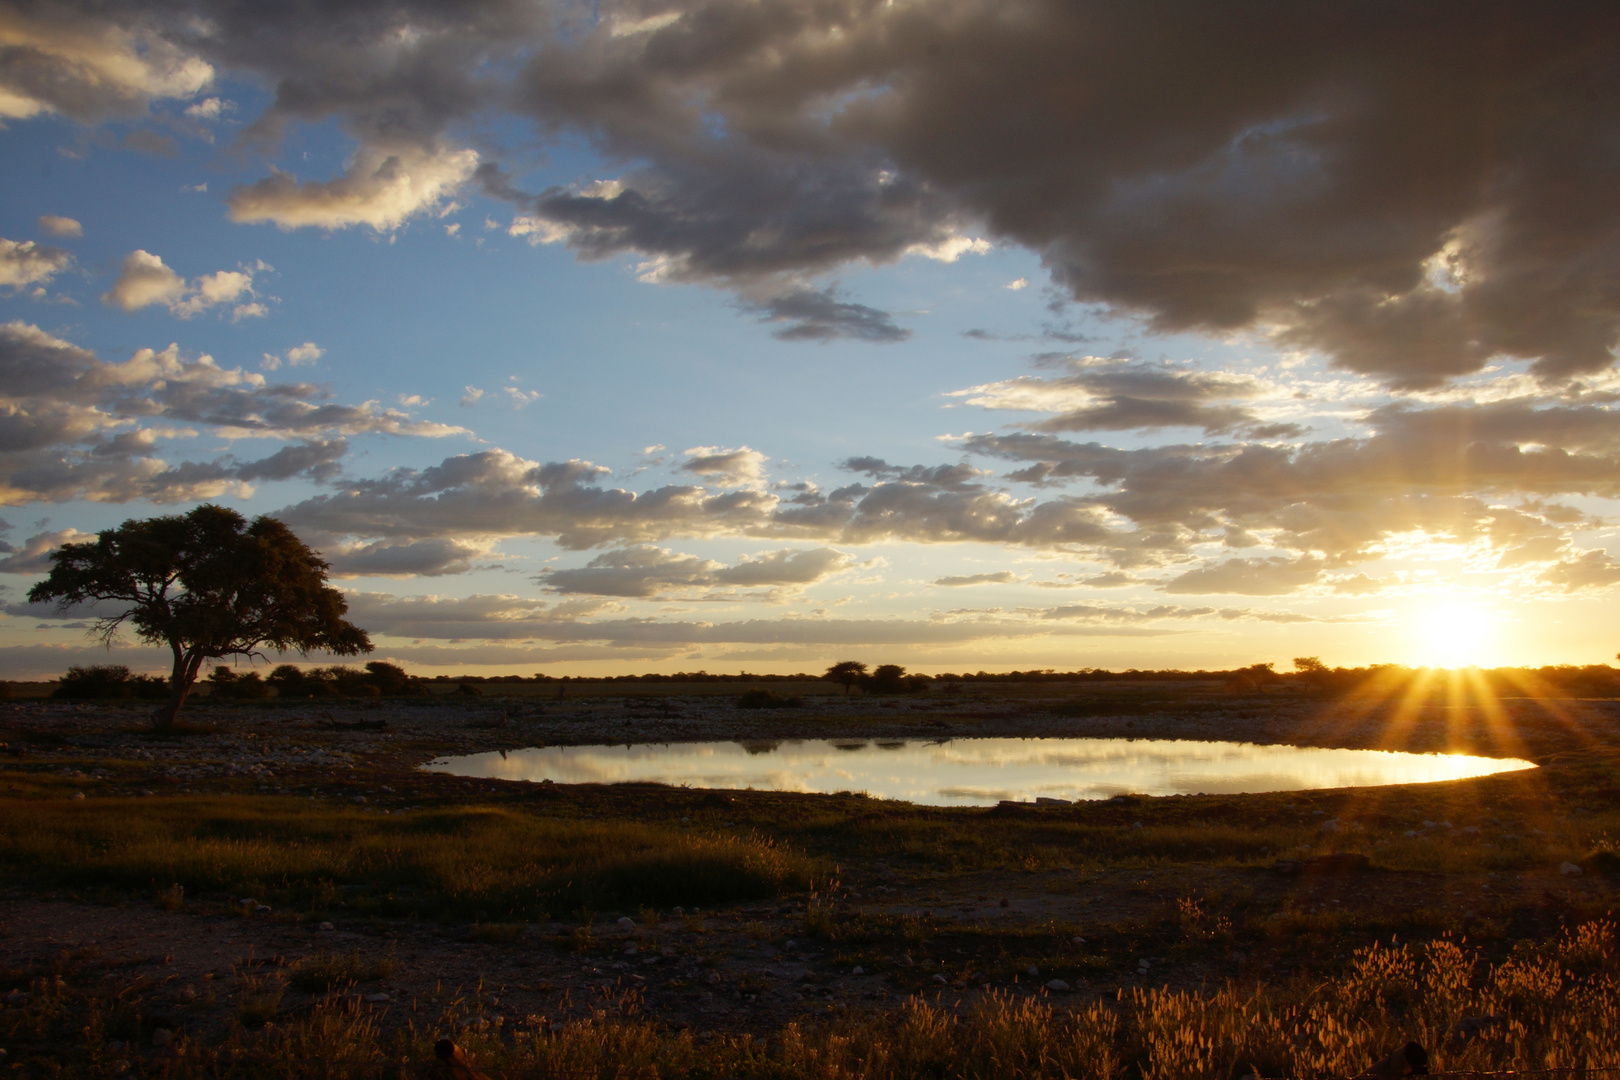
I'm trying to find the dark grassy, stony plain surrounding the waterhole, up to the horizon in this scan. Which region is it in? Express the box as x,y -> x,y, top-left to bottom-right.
0,669 -> 1620,1080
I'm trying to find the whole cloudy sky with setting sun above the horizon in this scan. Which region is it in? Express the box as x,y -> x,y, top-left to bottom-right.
0,0 -> 1620,678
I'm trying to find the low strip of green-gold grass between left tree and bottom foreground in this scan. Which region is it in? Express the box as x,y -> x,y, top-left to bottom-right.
0,795 -> 813,921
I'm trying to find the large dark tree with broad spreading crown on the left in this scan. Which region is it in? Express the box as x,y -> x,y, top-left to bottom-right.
28,504 -> 371,730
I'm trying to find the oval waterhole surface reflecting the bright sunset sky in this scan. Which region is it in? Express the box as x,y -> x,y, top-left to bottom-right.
424,738 -> 1534,806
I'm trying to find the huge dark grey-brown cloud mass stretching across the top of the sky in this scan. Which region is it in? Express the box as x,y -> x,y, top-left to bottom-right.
15,0 -> 1620,375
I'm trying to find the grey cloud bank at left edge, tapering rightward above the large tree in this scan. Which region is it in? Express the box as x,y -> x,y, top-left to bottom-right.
0,322 -> 465,502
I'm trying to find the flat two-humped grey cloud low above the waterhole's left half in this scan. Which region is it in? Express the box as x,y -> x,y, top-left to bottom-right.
541,544 -> 855,599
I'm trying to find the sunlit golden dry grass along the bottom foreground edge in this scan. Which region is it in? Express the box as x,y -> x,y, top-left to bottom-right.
0,920 -> 1620,1080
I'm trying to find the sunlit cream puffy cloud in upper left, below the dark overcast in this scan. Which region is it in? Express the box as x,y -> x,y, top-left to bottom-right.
225,146 -> 478,232
